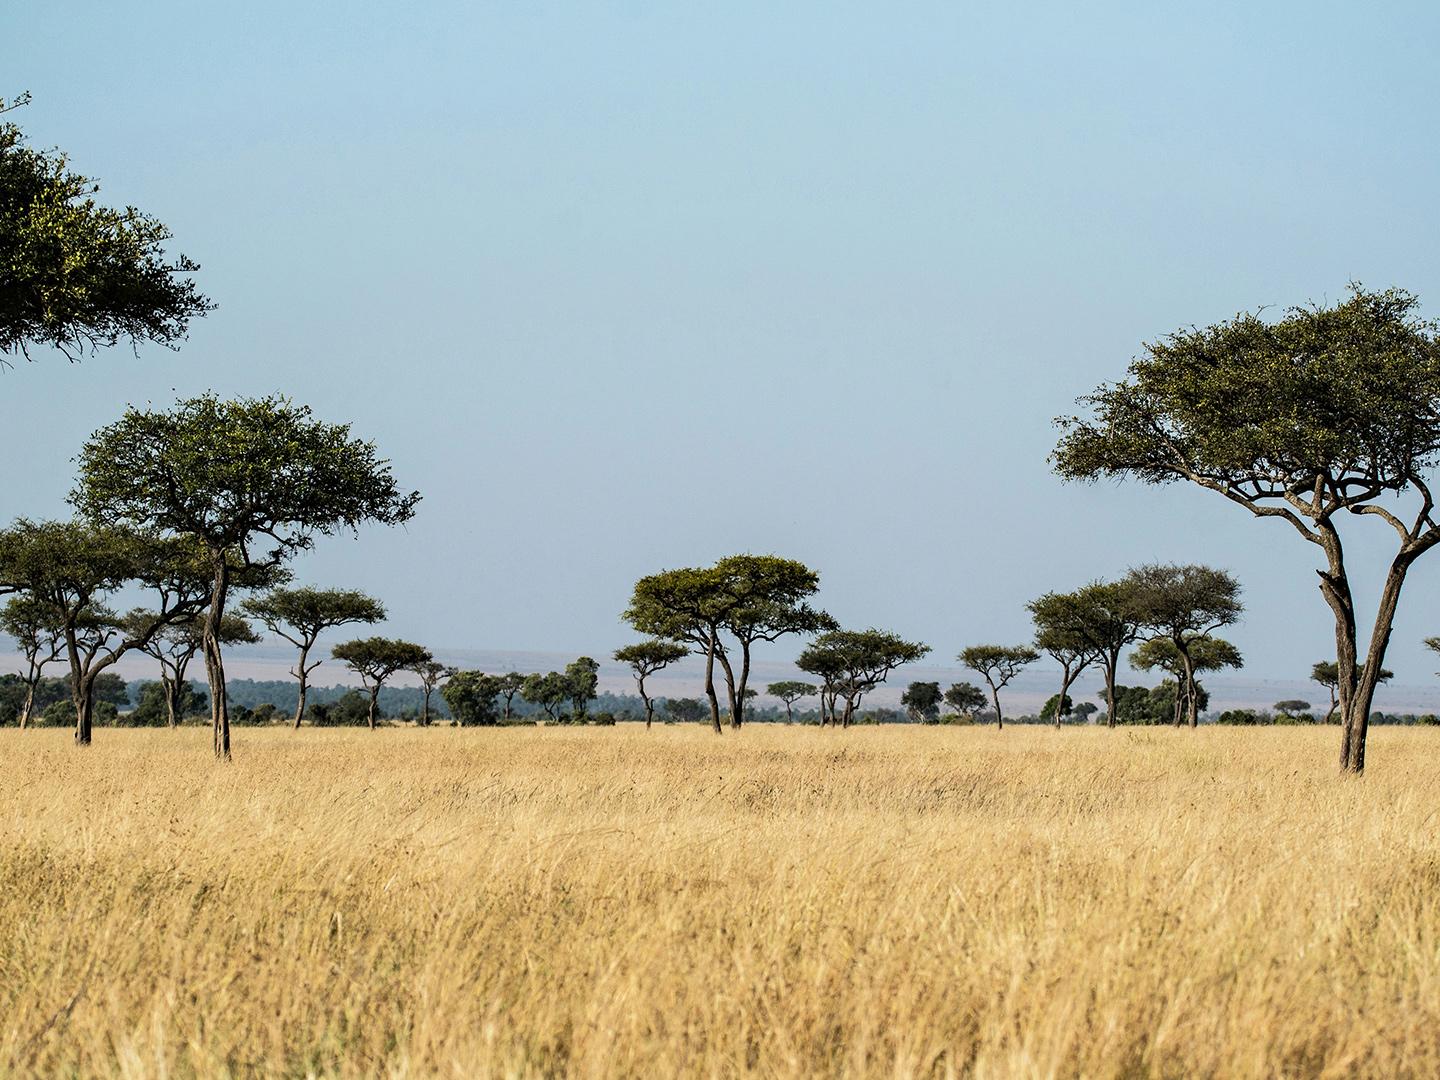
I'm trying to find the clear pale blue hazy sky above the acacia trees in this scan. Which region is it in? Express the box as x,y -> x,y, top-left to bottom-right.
8,0 -> 1440,681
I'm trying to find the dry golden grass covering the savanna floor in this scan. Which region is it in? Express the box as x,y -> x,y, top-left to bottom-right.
0,727 -> 1440,1077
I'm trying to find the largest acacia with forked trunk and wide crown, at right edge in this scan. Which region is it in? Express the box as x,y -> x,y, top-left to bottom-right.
1051,285 -> 1440,773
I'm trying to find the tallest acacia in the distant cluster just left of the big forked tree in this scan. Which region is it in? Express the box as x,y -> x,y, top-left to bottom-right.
1126,563 -> 1244,727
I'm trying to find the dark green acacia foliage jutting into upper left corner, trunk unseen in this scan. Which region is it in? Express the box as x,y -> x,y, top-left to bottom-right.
0,96 -> 213,361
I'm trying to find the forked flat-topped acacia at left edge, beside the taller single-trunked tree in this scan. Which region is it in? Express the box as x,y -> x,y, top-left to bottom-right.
0,518 -> 204,746
